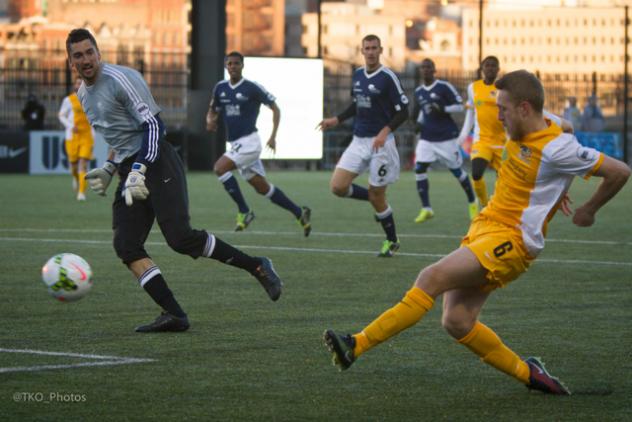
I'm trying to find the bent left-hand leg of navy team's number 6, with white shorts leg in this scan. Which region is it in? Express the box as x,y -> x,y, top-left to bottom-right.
329,136 -> 371,201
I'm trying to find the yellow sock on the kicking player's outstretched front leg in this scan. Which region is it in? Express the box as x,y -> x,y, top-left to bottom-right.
353,287 -> 434,358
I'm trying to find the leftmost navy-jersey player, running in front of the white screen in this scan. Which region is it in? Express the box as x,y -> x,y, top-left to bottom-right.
206,51 -> 312,237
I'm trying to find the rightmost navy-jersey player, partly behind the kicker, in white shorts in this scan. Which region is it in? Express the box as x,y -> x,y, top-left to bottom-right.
412,59 -> 478,223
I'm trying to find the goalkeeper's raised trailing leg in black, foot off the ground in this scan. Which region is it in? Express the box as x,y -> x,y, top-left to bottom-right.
150,143 -> 282,300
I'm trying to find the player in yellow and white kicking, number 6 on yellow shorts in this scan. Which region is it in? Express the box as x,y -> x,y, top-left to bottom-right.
324,70 -> 630,395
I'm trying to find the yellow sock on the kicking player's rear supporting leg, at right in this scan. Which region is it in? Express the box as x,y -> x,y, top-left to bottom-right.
459,322 -> 529,384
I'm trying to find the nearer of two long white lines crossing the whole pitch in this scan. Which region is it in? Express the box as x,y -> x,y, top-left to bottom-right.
0,232 -> 632,267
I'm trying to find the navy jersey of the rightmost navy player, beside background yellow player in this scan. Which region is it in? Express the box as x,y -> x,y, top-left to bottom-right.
415,79 -> 463,142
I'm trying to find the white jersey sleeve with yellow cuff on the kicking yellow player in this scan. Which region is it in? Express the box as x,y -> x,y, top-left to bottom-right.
543,134 -> 604,178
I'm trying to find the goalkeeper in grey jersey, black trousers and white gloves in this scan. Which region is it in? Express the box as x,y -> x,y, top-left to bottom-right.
66,29 -> 282,332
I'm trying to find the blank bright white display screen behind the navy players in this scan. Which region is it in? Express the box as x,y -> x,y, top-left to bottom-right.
224,57 -> 323,160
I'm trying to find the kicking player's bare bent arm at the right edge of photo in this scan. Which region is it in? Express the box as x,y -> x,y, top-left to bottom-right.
573,155 -> 630,227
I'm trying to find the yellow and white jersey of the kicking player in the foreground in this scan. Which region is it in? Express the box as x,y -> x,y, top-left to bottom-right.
481,120 -> 604,258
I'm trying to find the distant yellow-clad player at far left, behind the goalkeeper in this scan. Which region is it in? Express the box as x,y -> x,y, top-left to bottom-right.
58,78 -> 94,201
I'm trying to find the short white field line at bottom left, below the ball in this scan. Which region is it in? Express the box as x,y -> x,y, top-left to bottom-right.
0,348 -> 155,373
